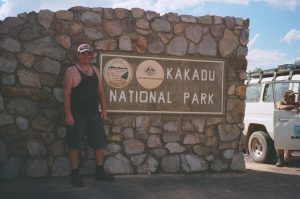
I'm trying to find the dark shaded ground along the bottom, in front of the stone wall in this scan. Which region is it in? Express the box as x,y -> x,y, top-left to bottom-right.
0,166 -> 300,199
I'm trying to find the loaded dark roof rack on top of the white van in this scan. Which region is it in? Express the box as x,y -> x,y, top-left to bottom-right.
247,64 -> 300,82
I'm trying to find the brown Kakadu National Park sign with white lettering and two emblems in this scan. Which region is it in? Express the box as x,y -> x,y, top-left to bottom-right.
99,54 -> 225,115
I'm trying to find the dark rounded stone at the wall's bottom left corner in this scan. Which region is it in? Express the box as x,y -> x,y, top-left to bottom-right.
1,156 -> 22,180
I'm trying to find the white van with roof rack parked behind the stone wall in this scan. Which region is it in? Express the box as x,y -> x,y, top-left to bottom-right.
243,64 -> 300,163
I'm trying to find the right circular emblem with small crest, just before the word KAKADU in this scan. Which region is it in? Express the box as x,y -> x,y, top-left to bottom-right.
136,60 -> 164,89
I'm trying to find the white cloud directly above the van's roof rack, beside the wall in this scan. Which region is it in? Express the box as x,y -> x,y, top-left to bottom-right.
247,49 -> 294,70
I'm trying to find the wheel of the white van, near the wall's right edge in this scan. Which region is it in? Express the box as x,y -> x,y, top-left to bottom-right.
248,131 -> 272,163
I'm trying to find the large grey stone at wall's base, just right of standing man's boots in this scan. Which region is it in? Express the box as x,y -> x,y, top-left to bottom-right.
104,153 -> 133,174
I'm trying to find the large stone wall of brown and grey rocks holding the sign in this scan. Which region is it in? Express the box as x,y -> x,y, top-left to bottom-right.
0,7 -> 249,179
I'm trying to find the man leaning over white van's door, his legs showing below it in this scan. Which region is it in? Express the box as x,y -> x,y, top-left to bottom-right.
276,90 -> 300,167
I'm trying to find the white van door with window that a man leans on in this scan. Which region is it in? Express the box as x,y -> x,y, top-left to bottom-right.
273,81 -> 300,150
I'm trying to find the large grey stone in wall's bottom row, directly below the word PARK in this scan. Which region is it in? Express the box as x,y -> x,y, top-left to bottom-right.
180,154 -> 209,173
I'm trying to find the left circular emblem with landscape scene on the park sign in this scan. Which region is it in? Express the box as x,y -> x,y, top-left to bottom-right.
103,58 -> 132,88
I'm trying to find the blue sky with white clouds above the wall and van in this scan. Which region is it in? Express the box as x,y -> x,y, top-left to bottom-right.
0,0 -> 300,71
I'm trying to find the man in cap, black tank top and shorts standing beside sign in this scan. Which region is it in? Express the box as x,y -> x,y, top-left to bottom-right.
64,44 -> 114,186
